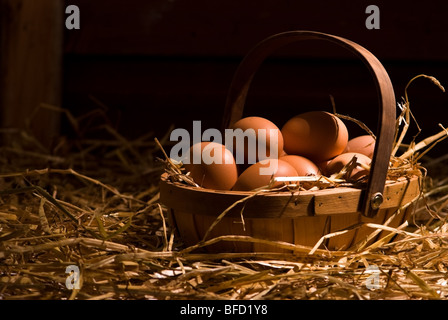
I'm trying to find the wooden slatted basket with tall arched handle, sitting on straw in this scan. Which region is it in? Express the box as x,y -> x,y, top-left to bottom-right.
160,31 -> 420,252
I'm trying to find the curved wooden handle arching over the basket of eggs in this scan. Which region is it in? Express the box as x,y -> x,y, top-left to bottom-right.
222,31 -> 396,217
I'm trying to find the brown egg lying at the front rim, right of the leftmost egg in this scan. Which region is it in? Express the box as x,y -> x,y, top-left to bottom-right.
232,159 -> 297,191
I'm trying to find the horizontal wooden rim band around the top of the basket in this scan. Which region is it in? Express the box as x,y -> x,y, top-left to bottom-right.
160,174 -> 421,218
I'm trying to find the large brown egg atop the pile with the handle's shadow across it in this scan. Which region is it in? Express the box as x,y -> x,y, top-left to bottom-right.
281,111 -> 348,163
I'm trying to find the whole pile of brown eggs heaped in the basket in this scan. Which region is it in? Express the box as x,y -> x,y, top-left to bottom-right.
184,111 -> 375,191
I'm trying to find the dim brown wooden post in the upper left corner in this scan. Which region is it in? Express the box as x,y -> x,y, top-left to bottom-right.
0,0 -> 65,147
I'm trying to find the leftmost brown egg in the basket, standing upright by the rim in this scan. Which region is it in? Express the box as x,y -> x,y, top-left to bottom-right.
184,142 -> 238,190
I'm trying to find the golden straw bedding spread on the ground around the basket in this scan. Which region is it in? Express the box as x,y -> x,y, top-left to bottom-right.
0,77 -> 448,300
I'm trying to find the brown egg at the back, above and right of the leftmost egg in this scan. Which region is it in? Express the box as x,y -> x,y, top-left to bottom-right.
231,117 -> 283,167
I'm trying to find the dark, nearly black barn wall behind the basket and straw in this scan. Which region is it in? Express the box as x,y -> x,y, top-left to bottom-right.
1,0 -> 448,156
